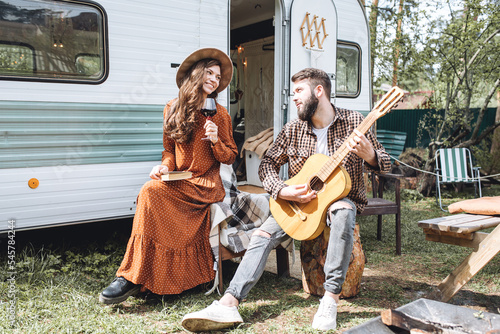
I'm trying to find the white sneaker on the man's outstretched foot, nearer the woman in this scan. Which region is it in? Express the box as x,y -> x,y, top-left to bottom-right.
182,301 -> 243,332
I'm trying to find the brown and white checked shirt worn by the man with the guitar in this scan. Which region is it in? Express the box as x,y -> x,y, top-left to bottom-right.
259,105 -> 391,213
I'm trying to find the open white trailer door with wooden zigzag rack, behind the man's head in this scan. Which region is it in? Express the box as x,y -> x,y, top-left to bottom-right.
284,0 -> 337,120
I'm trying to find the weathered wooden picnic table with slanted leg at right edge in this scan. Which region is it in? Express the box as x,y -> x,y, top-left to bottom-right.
418,214 -> 500,302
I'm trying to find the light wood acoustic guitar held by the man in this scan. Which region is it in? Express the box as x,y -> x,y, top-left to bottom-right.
269,87 -> 404,240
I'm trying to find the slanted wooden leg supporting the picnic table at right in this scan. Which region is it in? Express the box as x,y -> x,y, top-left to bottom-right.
438,225 -> 500,302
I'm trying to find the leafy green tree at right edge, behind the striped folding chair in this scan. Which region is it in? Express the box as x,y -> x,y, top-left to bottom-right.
419,0 -> 500,196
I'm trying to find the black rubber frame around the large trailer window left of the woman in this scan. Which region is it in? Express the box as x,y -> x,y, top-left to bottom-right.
0,0 -> 109,85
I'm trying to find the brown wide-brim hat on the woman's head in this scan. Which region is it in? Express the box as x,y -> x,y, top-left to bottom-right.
175,48 -> 233,93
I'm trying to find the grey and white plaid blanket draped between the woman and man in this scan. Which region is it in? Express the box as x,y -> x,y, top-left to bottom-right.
207,164 -> 293,294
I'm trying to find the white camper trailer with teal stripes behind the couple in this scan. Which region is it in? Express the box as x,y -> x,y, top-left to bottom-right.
0,0 -> 371,232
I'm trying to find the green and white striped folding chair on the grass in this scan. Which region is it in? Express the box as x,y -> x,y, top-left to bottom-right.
435,148 -> 482,212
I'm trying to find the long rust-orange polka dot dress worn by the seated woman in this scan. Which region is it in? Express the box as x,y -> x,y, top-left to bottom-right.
116,101 -> 237,295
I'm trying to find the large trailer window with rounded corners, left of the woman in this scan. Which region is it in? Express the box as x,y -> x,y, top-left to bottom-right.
0,0 -> 108,84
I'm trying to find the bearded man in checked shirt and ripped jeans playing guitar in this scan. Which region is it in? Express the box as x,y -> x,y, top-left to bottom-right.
182,68 -> 390,331
